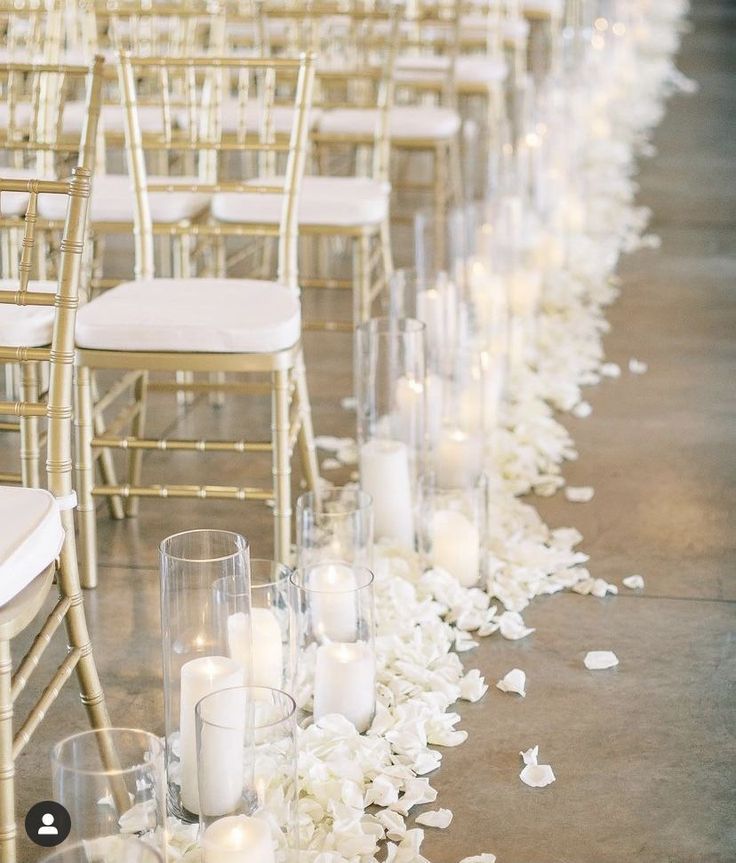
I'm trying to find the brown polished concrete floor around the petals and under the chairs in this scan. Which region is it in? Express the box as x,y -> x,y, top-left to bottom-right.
7,0 -> 736,863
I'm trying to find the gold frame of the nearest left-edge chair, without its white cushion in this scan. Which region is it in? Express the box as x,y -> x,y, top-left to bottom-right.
0,61 -> 110,863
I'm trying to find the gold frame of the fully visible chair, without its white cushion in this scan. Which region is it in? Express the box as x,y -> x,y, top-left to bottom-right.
76,54 -> 318,588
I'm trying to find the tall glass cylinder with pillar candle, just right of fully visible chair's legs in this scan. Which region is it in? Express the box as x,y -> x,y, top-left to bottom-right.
355,318 -> 427,549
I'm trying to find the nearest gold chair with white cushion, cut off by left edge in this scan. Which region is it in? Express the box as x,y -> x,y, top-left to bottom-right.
0,60 -> 110,863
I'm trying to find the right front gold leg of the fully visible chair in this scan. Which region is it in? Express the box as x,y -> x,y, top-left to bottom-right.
271,369 -> 291,564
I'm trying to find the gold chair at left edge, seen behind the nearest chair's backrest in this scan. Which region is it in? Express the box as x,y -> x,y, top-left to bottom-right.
0,61 -> 108,487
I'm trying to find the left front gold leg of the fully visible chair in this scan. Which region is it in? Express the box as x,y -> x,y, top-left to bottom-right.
74,366 -> 97,588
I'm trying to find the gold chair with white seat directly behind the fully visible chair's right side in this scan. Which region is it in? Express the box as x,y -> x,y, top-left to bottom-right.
212,3 -> 399,332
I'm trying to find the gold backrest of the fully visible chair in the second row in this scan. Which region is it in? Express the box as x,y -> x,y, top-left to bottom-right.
119,52 -> 314,290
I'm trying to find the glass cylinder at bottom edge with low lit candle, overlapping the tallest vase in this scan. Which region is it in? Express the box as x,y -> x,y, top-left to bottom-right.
197,686 -> 299,863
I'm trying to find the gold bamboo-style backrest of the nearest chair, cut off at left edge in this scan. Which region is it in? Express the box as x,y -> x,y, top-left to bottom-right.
0,60 -> 102,502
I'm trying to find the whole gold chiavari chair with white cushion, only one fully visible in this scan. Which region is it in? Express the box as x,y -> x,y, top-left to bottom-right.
72,55 -> 318,587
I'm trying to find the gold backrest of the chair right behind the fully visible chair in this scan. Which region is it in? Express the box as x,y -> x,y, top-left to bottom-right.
254,0 -> 401,180
